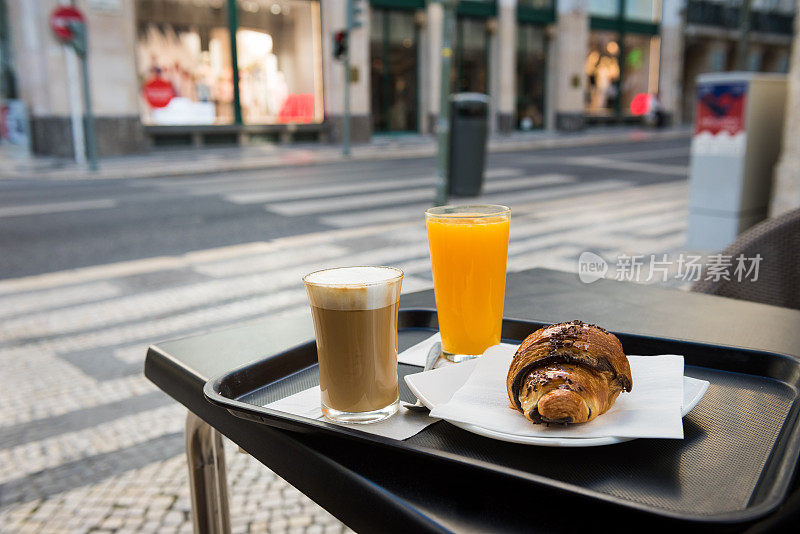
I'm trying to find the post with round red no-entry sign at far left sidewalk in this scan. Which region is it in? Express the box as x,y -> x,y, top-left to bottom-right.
50,6 -> 97,171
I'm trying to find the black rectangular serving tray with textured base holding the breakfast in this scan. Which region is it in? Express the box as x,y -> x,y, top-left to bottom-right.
203,310 -> 800,526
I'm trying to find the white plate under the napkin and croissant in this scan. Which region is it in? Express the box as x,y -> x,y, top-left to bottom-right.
405,360 -> 709,447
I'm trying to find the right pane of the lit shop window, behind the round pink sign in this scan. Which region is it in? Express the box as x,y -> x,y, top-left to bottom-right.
622,34 -> 660,115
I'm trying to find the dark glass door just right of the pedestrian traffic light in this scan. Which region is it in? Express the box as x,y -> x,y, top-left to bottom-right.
370,8 -> 419,132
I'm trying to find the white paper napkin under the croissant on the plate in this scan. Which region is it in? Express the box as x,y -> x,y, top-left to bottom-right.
431,345 -> 683,439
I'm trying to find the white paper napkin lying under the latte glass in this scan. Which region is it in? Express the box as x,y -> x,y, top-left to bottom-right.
266,386 -> 439,440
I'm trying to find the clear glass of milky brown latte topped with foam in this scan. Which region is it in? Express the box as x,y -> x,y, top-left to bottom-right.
303,267 -> 403,423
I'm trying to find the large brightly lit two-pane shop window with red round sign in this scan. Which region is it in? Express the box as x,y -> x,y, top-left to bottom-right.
136,0 -> 322,125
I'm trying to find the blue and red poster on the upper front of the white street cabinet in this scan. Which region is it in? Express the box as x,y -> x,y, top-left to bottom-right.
694,82 -> 747,135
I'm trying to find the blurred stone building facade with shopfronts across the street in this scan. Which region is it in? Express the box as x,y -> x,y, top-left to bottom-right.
0,0 -> 797,156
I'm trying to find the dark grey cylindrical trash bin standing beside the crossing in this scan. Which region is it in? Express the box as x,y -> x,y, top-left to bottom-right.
447,93 -> 489,197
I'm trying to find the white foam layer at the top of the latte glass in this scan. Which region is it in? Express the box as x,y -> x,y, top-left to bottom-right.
303,267 -> 403,310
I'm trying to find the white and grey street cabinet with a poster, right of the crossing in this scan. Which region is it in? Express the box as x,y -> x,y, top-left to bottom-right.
687,72 -> 786,250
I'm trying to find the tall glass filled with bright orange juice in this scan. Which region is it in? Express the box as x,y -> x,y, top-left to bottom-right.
425,205 -> 511,362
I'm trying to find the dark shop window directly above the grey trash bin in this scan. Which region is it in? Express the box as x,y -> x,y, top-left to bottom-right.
452,17 -> 489,94
